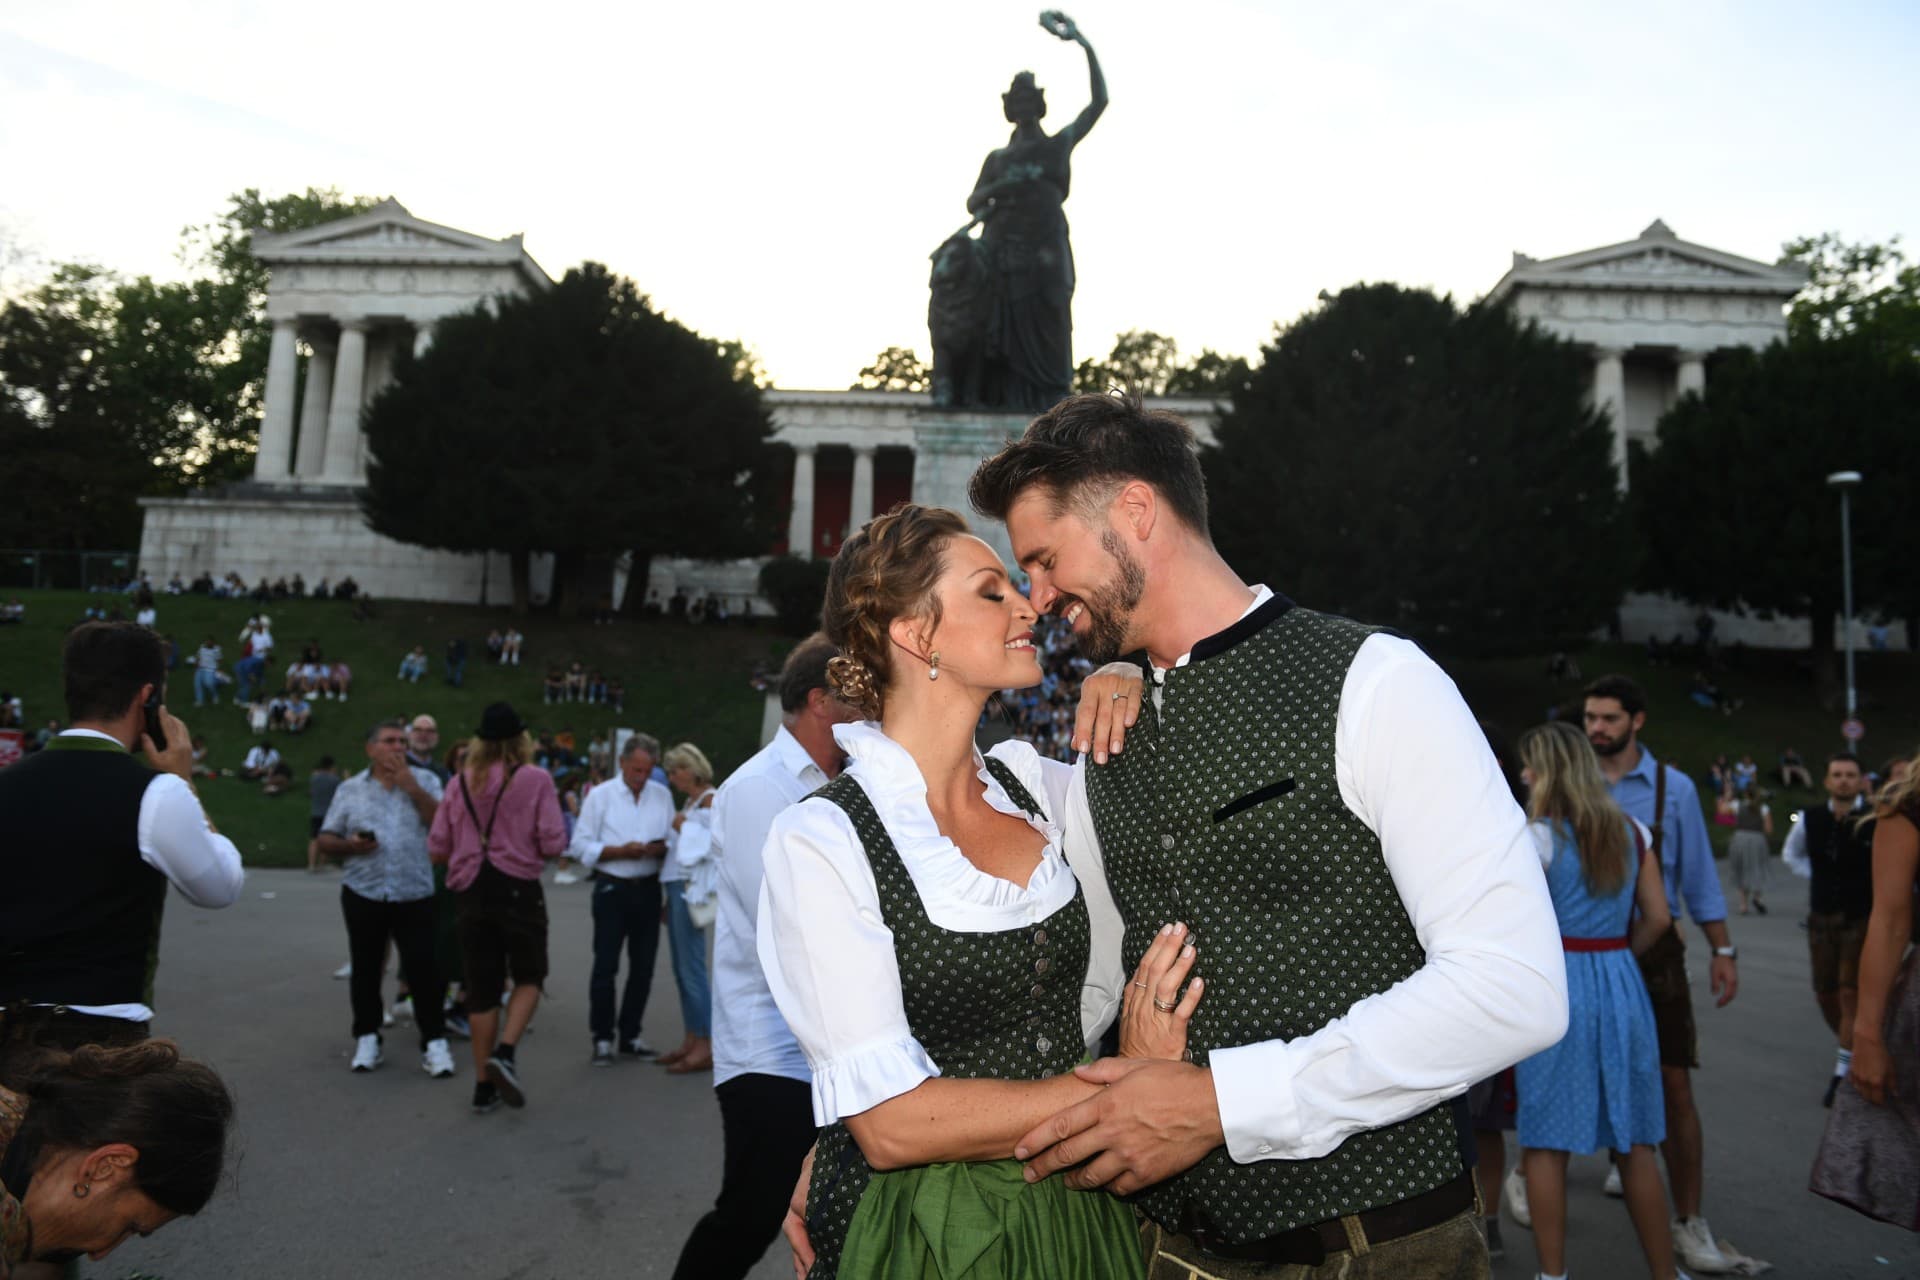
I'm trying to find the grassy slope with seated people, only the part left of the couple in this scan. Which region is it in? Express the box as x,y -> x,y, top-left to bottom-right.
0,591 -> 791,867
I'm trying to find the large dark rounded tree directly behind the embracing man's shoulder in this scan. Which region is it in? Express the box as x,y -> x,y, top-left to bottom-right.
1202,284 -> 1630,654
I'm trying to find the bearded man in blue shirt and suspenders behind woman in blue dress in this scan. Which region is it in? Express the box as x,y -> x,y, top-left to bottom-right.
1586,676 -> 1740,1270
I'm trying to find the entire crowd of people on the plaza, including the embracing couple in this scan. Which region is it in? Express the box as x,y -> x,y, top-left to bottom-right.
0,395 -> 1920,1280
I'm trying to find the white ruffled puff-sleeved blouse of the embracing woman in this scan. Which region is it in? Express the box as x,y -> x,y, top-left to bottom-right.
758,723 -> 1110,1125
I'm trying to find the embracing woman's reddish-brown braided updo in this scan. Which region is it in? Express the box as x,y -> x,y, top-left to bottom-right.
820,503 -> 968,720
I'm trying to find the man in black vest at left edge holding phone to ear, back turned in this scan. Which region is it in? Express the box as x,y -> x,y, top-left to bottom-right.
0,622 -> 242,1050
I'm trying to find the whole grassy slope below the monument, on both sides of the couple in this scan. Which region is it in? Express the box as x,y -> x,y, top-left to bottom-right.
0,591 -> 1920,865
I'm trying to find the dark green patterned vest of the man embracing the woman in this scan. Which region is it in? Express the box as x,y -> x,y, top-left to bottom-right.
1087,597 -> 1461,1244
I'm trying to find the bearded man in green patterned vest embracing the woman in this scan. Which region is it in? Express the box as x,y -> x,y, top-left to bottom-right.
970,395 -> 1567,1280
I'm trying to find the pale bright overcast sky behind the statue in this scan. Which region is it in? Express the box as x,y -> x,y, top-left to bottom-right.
0,0 -> 1920,388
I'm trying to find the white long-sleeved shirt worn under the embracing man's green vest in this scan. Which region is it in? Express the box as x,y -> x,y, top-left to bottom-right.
1066,587 -> 1567,1163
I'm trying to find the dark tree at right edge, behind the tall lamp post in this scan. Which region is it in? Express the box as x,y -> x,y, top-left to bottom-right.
1632,332 -> 1920,676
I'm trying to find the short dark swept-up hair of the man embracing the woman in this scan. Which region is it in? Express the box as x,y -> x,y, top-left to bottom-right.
968,391 -> 1212,537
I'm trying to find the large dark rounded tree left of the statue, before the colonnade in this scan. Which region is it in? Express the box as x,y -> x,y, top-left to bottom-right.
361,263 -> 778,612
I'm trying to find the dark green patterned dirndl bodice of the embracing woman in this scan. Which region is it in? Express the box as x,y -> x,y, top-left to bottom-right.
806,756 -> 1092,1280
